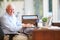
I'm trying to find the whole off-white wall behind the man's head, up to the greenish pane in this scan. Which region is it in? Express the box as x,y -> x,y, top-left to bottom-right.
1,0 -> 34,15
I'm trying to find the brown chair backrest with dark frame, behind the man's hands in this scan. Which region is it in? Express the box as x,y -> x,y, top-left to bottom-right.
22,15 -> 38,27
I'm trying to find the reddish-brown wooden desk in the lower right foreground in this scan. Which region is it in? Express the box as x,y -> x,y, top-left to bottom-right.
32,29 -> 60,40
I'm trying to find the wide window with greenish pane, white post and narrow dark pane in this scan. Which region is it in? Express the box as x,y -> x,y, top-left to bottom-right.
34,0 -> 52,19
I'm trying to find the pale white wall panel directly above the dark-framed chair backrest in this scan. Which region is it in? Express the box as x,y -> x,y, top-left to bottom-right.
24,0 -> 34,15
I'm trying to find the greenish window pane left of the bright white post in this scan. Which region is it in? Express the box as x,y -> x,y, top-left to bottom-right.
34,0 -> 43,19
